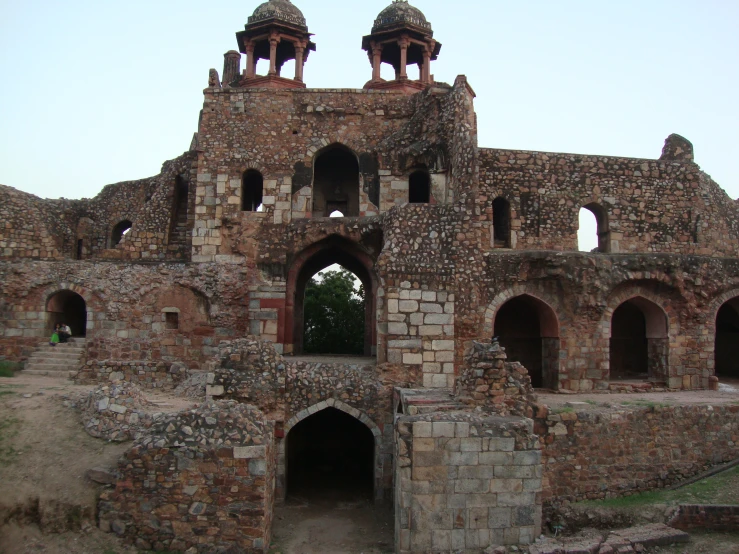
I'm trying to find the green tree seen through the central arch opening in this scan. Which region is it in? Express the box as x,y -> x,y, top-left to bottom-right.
303,270 -> 365,355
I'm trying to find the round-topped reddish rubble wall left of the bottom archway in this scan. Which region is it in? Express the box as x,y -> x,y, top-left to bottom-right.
99,402 -> 275,554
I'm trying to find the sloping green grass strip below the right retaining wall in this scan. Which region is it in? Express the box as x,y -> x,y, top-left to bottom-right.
583,466 -> 739,508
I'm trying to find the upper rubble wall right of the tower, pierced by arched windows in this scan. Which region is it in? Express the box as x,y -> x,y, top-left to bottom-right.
479,143 -> 739,256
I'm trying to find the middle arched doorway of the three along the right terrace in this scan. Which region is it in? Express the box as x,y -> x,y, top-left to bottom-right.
610,297 -> 670,382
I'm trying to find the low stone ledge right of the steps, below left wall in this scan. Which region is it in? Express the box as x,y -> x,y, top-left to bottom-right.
74,360 -> 187,390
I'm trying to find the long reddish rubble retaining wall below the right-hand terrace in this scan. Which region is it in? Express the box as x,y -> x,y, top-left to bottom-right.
535,406 -> 739,504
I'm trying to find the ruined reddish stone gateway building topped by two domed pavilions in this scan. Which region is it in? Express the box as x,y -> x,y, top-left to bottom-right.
0,0 -> 739,552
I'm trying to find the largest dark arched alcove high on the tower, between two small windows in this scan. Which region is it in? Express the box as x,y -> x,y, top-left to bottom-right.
313,144 -> 359,217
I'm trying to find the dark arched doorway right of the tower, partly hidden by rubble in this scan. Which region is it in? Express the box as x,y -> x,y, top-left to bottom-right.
494,295 -> 559,390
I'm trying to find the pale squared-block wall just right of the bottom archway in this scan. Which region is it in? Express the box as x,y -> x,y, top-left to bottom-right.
395,412 -> 542,554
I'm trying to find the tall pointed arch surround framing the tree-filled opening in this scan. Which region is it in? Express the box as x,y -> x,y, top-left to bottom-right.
285,236 -> 378,356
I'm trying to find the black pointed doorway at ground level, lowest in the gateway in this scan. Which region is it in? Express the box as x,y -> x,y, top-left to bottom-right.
286,408 -> 375,501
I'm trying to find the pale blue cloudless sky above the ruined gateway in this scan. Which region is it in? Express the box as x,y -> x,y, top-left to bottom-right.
0,0 -> 739,250
